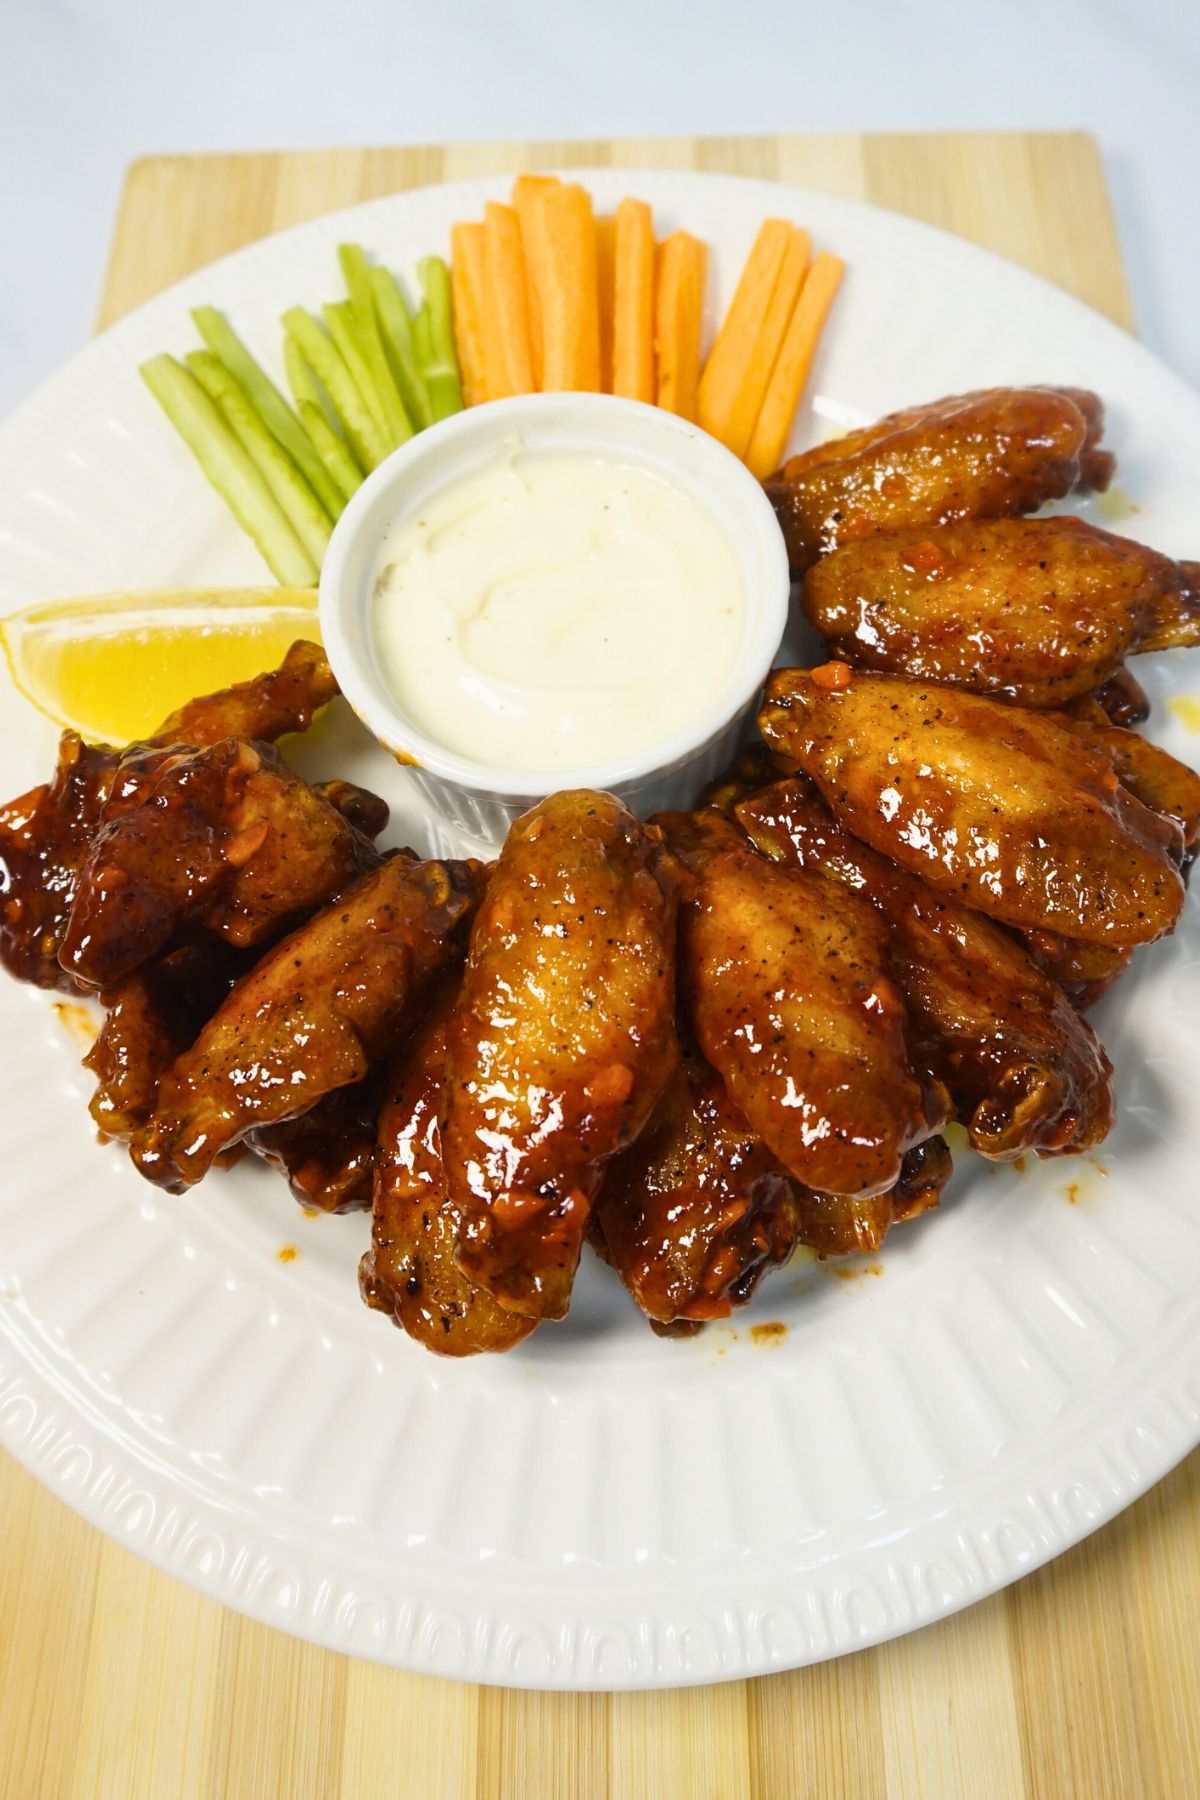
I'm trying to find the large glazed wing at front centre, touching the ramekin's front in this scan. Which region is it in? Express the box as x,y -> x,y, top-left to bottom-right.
441,788 -> 678,1319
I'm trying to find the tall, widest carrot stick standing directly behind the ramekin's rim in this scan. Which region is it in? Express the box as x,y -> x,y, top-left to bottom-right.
531,182 -> 599,392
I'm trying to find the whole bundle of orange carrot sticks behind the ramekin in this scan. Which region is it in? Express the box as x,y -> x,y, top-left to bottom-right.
452,175 -> 844,481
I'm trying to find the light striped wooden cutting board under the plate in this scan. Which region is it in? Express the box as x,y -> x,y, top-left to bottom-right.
0,133 -> 1200,1800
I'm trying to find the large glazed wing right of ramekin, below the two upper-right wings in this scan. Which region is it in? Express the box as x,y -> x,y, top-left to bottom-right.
759,662 -> 1184,947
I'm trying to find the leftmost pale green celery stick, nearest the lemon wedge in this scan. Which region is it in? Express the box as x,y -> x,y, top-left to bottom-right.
140,356 -> 317,587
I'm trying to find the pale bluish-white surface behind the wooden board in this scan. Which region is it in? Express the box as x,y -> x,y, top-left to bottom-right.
0,0 -> 1200,414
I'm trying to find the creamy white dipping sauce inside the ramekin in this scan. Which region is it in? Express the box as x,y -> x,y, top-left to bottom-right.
374,443 -> 745,770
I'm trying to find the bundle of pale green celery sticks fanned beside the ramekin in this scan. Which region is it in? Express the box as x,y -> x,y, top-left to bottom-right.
140,243 -> 462,587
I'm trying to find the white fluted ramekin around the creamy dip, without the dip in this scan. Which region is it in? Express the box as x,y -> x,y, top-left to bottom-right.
320,394 -> 788,851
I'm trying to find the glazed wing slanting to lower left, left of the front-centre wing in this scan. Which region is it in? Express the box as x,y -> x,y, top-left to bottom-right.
130,855 -> 482,1190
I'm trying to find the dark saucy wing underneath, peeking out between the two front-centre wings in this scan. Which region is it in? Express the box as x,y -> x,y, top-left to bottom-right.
597,1048 -> 950,1325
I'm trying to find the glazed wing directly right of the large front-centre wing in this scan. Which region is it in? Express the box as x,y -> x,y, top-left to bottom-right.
662,812 -> 946,1197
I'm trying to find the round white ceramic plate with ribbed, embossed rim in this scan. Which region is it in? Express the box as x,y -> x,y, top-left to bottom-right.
0,171 -> 1200,1688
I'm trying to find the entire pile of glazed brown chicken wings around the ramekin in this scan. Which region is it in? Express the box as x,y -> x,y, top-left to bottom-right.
0,387 -> 1200,1355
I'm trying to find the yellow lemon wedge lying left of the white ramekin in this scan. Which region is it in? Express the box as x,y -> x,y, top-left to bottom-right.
0,587 -> 320,743
